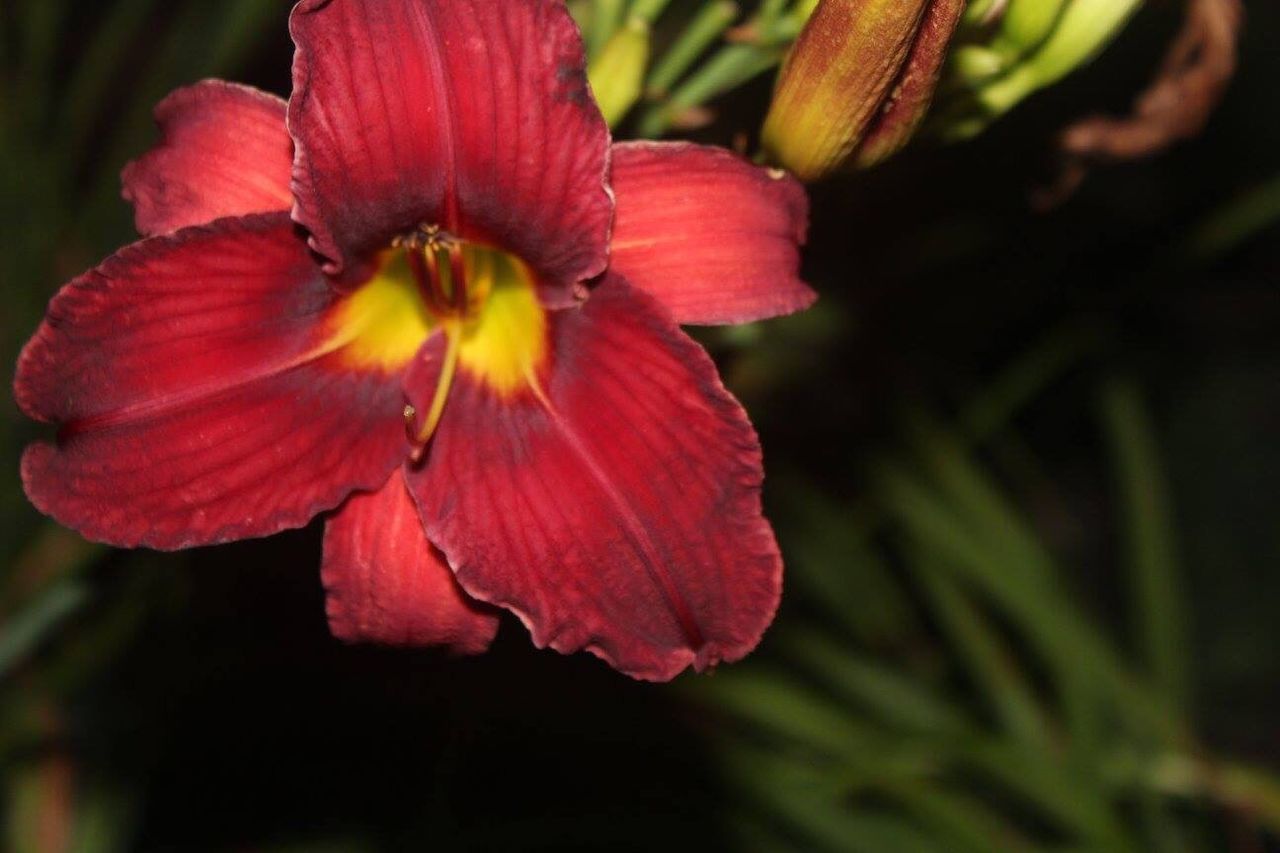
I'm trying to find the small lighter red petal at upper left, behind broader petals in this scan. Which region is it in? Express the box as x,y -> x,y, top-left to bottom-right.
122,79 -> 293,234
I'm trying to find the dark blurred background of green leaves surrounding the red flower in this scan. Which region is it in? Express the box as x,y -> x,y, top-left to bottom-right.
0,0 -> 1280,853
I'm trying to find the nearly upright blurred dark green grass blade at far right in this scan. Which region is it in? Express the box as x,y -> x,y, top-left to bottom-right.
1100,379 -> 1189,707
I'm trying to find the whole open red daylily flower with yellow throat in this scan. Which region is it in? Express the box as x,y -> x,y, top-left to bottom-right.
14,0 -> 813,679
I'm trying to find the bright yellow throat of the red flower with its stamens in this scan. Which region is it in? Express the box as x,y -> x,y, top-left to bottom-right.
322,225 -> 548,457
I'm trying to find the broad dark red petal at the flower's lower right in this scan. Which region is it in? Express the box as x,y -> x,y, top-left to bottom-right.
410,277 -> 782,680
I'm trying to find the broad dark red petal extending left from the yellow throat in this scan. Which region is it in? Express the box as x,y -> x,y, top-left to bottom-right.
14,213 -> 407,548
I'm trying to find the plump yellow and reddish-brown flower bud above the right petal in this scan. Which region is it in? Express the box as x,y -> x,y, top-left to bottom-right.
763,0 -> 964,181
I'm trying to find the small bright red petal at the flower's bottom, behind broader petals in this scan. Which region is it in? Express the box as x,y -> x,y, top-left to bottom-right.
320,471 -> 498,654
